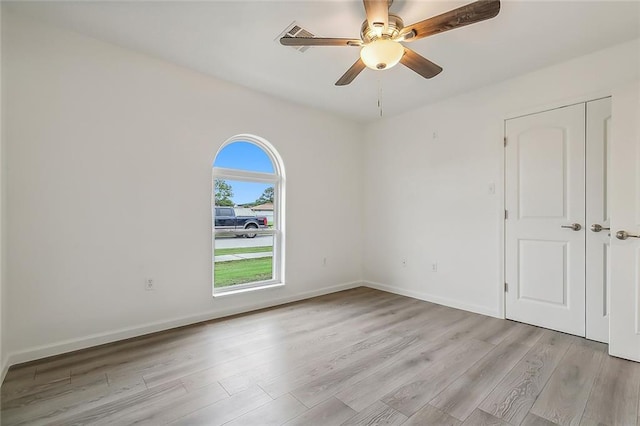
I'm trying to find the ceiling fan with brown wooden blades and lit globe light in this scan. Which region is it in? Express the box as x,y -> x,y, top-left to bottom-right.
280,0 -> 500,86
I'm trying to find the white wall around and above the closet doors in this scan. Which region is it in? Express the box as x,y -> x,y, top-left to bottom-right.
363,40 -> 640,316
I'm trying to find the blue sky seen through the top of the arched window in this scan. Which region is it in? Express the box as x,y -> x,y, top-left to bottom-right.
213,142 -> 274,204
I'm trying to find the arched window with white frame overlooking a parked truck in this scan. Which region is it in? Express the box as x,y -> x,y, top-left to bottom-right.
211,135 -> 284,296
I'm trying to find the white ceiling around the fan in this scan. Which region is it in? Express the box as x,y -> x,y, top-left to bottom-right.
3,0 -> 640,121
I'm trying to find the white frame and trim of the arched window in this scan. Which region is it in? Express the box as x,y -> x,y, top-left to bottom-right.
211,134 -> 285,297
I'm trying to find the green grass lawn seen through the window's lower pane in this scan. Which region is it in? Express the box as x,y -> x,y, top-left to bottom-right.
214,256 -> 273,288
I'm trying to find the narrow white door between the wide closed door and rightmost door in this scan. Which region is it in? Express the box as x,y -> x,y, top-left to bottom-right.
585,98 -> 611,343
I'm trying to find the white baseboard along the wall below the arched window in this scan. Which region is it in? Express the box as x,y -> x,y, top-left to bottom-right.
5,281 -> 363,368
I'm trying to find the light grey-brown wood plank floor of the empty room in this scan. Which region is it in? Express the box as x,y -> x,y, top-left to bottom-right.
1,288 -> 640,426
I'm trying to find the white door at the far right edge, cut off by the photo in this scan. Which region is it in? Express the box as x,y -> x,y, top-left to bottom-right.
609,83 -> 640,361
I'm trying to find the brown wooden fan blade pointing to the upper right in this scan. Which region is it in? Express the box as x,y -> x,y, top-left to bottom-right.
402,0 -> 500,41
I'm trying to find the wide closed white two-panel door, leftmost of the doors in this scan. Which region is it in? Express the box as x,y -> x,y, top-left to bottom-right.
505,104 -> 585,336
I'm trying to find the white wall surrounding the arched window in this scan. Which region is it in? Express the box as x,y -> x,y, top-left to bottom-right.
2,11 -> 362,363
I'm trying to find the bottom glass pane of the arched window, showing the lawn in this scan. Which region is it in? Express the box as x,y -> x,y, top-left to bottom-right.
213,235 -> 274,289
